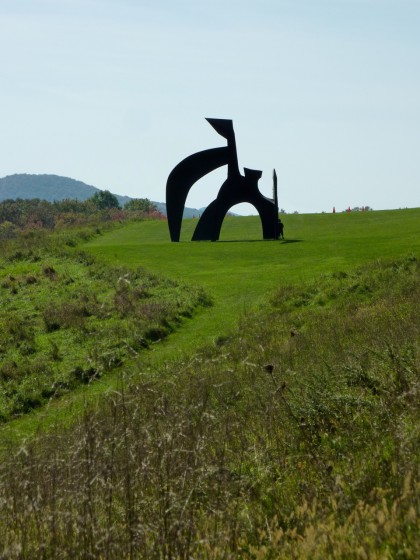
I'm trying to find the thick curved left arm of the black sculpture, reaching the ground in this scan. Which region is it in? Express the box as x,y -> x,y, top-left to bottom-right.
166,146 -> 229,241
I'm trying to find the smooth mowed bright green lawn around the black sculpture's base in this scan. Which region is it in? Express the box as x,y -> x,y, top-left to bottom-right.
86,208 -> 420,360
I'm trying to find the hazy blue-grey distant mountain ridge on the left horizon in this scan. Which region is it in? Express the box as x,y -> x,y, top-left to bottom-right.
0,173 -> 204,218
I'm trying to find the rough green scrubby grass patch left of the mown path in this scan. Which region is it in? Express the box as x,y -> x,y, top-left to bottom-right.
0,231 -> 211,422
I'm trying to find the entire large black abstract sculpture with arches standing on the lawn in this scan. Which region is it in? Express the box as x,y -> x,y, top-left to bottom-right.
166,119 -> 279,241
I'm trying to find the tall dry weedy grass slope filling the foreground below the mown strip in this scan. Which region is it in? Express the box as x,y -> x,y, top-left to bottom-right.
0,257 -> 420,560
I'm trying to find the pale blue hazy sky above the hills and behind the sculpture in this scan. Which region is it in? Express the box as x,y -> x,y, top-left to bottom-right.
0,0 -> 420,214
